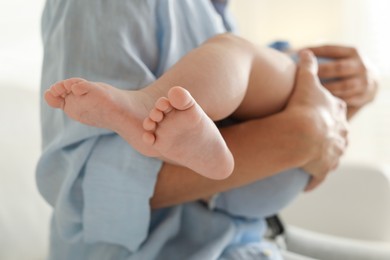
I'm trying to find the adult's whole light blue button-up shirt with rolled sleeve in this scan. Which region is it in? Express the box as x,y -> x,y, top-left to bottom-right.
37,0 -> 308,260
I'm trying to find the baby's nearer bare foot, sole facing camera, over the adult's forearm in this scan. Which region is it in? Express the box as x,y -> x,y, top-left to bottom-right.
143,87 -> 234,179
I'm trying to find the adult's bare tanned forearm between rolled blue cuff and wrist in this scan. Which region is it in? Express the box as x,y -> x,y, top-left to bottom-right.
151,112 -> 312,208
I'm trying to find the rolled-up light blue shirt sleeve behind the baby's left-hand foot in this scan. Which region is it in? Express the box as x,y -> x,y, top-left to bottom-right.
37,0 -> 161,251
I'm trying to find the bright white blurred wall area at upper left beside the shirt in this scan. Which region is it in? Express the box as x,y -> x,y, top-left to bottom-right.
0,0 -> 44,90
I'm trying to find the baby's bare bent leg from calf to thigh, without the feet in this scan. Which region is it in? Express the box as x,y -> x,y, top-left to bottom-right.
142,34 -> 296,121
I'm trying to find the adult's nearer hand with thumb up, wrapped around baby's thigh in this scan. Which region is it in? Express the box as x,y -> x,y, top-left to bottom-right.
286,50 -> 348,190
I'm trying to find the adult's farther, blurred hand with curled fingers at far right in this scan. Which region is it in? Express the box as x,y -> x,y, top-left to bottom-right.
309,45 -> 378,116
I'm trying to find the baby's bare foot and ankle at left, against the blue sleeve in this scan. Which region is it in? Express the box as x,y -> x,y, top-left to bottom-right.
45,78 -> 160,156
